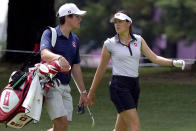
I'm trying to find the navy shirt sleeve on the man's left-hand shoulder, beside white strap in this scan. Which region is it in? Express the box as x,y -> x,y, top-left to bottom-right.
40,29 -> 52,51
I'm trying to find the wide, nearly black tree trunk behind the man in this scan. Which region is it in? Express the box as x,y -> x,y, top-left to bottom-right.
5,0 -> 55,63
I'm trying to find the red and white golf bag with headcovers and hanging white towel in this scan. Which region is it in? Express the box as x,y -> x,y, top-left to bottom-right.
0,61 -> 68,128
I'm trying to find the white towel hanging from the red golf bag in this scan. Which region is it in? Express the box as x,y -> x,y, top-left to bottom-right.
22,74 -> 43,122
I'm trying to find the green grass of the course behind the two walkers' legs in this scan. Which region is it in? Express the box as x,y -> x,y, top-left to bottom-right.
0,65 -> 196,131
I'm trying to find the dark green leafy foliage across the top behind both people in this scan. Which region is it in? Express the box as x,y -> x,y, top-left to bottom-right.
54,0 -> 196,46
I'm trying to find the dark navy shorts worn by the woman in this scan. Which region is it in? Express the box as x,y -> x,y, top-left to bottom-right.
110,75 -> 140,113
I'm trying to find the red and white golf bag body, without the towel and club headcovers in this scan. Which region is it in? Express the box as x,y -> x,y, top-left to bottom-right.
0,71 -> 33,128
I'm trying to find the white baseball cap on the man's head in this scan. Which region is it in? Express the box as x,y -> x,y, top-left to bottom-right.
58,3 -> 86,17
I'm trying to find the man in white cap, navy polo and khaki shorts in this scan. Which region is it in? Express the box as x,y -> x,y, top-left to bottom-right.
40,3 -> 87,131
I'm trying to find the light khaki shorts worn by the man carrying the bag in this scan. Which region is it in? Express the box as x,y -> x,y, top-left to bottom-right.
45,85 -> 73,121
